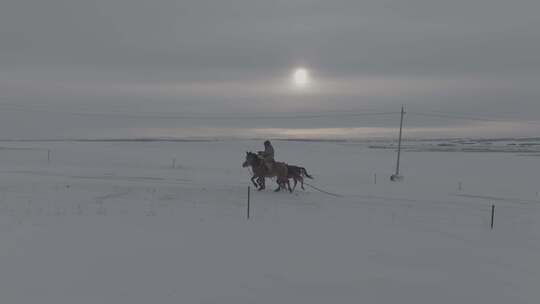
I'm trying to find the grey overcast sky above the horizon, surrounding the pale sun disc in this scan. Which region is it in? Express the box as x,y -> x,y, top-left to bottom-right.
0,0 -> 540,139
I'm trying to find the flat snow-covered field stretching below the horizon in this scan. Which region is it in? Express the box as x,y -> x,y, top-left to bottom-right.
0,140 -> 540,304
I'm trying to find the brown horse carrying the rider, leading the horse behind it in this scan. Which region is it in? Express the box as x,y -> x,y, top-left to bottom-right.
242,152 -> 292,192
